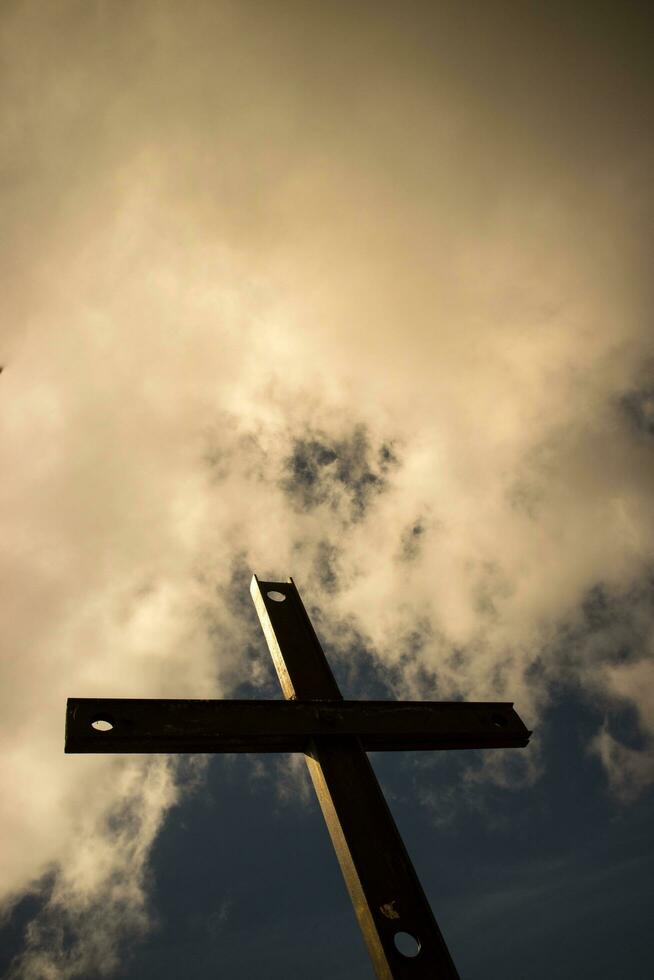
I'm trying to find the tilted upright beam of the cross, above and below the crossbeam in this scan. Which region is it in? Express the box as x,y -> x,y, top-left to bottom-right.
250,576 -> 459,980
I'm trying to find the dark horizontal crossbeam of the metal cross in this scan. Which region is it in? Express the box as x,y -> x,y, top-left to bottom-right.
65,698 -> 531,753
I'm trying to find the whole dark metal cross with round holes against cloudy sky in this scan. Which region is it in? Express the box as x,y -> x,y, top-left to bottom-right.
65,575 -> 531,980
